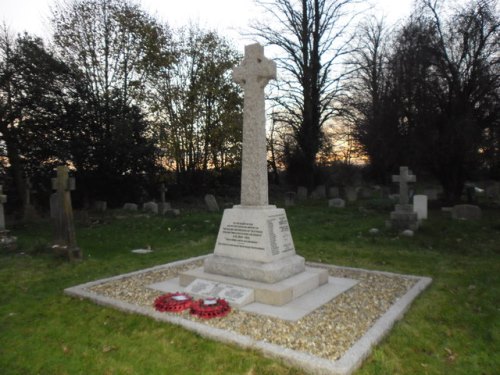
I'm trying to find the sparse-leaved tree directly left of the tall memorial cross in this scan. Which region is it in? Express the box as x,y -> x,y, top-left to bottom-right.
149,25 -> 242,187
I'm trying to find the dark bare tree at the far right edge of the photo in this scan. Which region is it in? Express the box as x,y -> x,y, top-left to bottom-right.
421,0 -> 500,201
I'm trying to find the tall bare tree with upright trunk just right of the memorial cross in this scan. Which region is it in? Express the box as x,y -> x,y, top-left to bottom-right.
253,0 -> 362,188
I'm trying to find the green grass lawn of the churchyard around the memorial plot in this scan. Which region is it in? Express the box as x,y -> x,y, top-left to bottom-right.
0,202 -> 500,375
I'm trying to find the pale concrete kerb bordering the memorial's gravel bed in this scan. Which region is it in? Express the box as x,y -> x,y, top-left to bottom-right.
64,254 -> 432,375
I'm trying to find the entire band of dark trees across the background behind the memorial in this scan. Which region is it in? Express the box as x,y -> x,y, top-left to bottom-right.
0,0 -> 500,210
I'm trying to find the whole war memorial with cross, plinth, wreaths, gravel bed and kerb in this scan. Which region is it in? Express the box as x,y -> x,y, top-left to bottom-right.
65,44 -> 431,374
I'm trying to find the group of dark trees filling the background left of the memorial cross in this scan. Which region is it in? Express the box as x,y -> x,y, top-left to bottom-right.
0,0 -> 241,210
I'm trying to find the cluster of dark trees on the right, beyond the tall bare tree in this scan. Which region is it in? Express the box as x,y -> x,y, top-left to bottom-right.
348,0 -> 500,201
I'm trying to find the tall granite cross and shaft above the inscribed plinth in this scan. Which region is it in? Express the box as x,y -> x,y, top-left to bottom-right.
233,43 -> 276,206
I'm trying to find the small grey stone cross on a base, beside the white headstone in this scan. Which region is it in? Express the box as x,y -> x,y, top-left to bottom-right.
389,167 -> 418,231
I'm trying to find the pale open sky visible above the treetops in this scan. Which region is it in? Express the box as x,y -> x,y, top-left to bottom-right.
0,0 -> 413,47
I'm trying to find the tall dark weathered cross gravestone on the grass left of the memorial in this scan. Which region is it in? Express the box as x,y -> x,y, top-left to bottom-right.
52,165 -> 82,260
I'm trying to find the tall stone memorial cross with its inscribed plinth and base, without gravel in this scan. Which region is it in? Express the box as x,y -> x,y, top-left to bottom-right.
179,43 -> 328,304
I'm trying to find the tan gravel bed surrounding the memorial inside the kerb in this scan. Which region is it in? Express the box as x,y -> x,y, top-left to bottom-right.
85,258 -> 420,361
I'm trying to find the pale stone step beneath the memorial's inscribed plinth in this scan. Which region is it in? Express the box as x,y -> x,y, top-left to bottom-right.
179,267 -> 328,306
